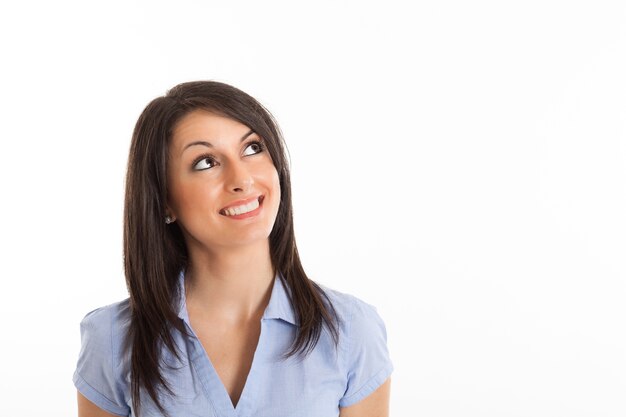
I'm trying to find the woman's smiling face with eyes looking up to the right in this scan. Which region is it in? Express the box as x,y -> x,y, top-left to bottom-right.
167,110 -> 280,250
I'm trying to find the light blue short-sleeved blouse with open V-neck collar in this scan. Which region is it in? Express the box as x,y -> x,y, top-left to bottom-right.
73,273 -> 393,417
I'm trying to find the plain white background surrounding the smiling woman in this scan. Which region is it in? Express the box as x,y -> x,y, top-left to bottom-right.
0,0 -> 626,417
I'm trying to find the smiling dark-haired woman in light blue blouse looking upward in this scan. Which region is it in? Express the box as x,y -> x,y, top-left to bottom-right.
74,82 -> 393,417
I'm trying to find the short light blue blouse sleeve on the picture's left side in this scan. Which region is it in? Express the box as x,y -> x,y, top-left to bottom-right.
73,305 -> 130,416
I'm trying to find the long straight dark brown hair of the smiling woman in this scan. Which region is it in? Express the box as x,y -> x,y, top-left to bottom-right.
124,81 -> 339,414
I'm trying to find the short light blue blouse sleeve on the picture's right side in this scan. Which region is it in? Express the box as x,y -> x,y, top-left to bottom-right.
339,298 -> 393,407
